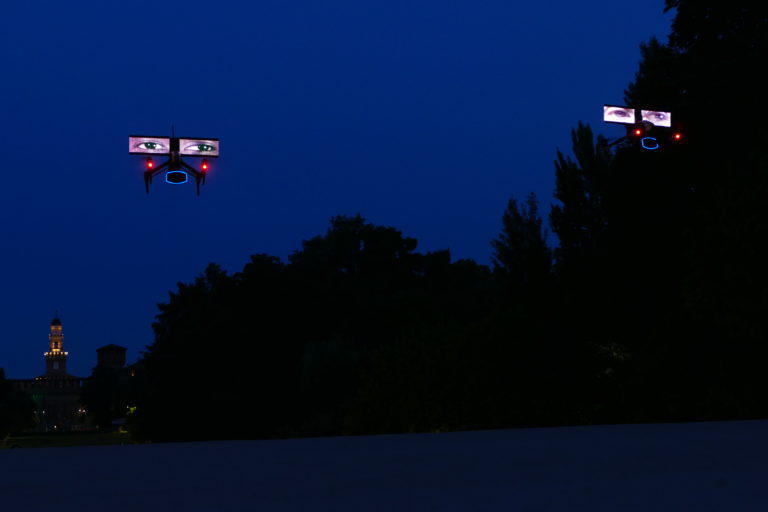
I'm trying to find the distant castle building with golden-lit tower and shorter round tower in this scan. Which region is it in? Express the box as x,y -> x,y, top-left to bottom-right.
8,317 -> 126,432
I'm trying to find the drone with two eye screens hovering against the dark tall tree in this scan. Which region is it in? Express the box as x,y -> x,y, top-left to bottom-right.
603,105 -> 683,151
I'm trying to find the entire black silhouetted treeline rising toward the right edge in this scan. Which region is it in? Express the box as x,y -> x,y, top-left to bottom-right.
120,0 -> 768,440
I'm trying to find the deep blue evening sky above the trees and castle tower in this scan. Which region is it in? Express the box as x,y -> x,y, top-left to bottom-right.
0,0 -> 671,378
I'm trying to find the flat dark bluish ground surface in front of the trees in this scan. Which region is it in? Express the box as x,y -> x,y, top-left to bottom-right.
0,421 -> 768,512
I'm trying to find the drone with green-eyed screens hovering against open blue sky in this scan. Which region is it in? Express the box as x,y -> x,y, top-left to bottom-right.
128,130 -> 219,196
